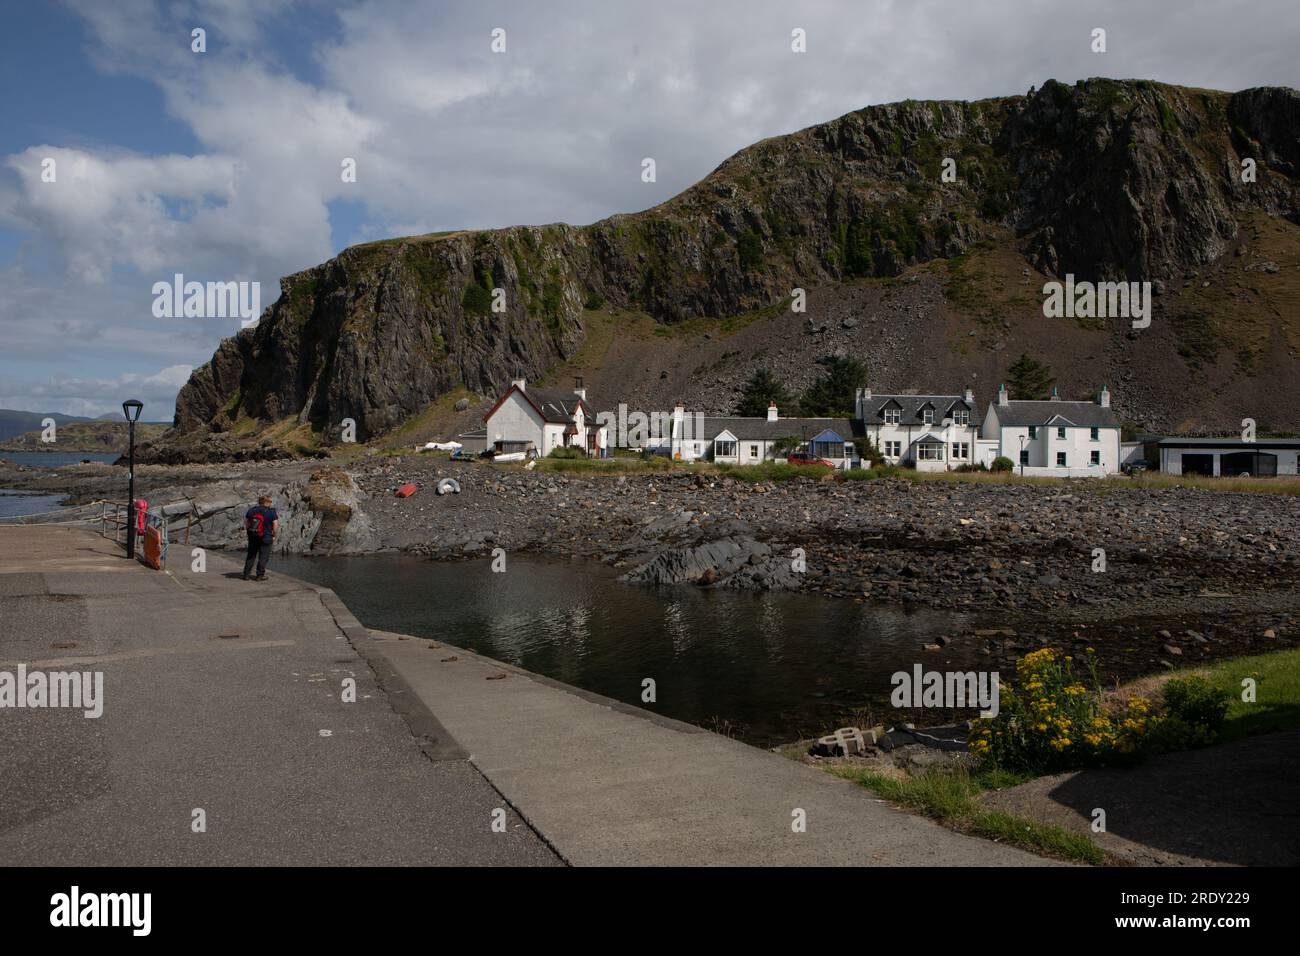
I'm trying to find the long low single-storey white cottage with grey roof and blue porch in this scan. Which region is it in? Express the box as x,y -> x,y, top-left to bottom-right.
655,405 -> 862,468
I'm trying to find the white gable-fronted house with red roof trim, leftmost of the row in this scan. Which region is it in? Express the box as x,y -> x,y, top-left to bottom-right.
484,378 -> 610,458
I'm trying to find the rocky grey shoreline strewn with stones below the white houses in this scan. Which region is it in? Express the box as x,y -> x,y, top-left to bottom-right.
0,455 -> 1300,676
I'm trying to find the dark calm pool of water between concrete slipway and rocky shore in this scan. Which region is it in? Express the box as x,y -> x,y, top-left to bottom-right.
273,554 -> 988,745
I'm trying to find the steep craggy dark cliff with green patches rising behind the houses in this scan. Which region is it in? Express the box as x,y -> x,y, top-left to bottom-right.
144,79 -> 1300,460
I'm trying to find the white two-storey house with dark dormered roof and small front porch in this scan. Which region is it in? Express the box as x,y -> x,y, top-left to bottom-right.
854,389 -> 992,471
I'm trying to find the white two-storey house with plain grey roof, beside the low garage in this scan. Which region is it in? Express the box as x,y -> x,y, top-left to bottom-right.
982,385 -> 1121,477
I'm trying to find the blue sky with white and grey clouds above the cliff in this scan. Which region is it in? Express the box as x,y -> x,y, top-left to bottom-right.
0,0 -> 1300,421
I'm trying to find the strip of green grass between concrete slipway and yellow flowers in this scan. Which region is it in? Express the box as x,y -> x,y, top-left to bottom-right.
827,763 -> 1105,864
